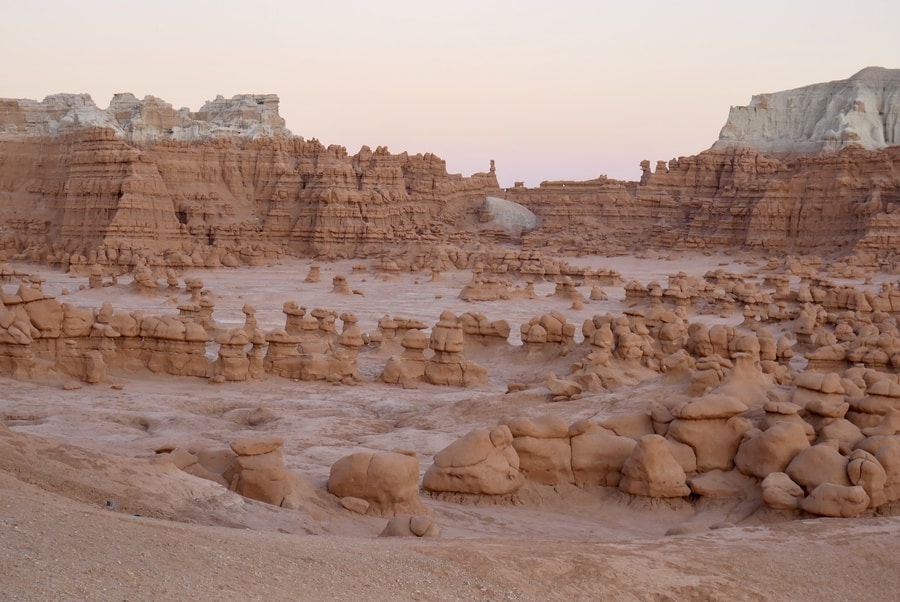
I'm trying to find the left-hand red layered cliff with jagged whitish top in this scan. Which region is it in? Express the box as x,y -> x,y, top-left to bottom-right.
0,94 -> 499,263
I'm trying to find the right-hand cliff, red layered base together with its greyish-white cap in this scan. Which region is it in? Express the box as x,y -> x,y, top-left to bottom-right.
507,67 -> 900,259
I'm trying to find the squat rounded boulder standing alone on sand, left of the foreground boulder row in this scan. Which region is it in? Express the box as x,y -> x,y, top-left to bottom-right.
328,452 -> 424,517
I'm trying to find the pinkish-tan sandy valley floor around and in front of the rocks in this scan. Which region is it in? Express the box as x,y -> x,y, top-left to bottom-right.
0,251 -> 900,600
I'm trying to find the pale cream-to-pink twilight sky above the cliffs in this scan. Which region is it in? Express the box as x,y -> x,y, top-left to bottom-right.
0,0 -> 900,186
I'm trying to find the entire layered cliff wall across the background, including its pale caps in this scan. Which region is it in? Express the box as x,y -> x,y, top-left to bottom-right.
0,77 -> 900,269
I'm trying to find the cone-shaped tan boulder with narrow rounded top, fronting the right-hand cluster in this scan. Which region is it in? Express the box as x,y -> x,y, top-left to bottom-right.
619,435 -> 691,497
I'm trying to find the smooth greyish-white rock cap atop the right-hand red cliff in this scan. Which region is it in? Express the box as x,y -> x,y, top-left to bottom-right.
713,67 -> 900,154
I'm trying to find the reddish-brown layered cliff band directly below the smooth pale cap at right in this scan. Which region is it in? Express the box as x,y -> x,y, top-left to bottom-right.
506,146 -> 900,256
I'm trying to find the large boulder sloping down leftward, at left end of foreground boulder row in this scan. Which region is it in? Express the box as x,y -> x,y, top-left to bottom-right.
422,426 -> 525,495
